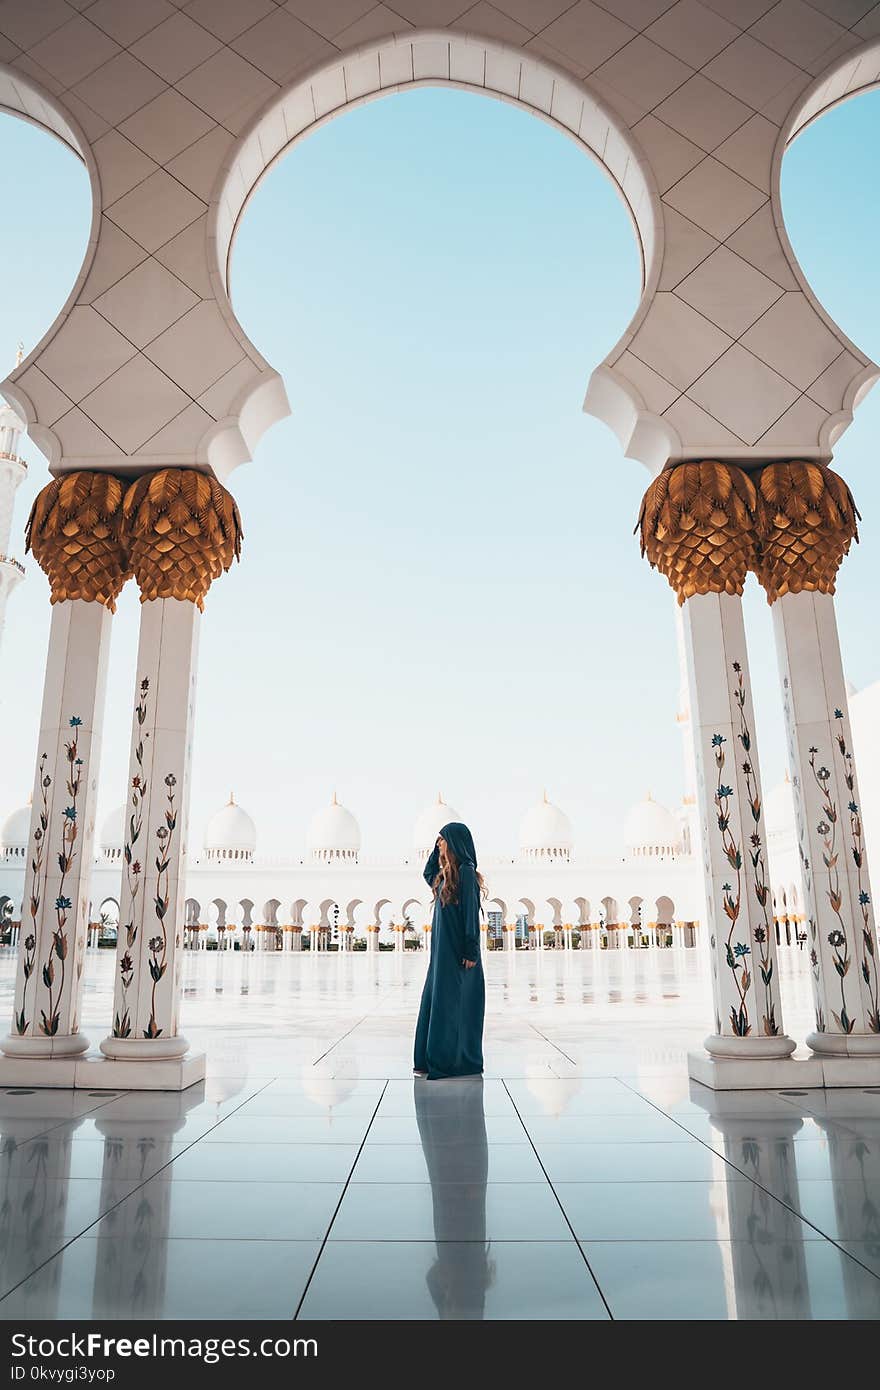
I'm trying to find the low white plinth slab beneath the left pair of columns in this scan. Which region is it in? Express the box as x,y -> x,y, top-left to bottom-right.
0,1052 -> 204,1091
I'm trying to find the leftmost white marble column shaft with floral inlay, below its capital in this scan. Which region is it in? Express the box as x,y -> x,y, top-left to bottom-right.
3,599 -> 110,1061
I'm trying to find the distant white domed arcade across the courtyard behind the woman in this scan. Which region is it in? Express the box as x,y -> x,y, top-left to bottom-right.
0,794 -> 703,949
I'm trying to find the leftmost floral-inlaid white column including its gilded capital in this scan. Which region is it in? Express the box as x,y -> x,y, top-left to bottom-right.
3,473 -> 125,1067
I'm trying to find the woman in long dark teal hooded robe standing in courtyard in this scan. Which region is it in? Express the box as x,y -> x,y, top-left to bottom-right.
413,821 -> 485,1081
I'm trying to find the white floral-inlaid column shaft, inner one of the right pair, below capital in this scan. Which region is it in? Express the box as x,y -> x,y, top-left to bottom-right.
683,594 -> 795,1086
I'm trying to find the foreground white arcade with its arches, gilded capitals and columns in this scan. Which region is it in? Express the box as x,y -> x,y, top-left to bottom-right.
0,0 -> 880,1088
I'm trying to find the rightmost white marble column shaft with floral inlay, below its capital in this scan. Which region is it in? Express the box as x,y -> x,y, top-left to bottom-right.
772,592 -> 880,1056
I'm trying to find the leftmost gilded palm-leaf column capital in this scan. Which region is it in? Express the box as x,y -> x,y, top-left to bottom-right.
25,473 -> 131,613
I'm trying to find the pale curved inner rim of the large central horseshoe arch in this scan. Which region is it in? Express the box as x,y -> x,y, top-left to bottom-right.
205,29 -> 658,478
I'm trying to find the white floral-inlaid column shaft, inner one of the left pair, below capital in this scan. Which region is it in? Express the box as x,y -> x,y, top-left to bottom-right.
101,598 -> 202,1063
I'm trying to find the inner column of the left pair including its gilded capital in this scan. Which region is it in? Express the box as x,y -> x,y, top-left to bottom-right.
101,468 -> 241,1084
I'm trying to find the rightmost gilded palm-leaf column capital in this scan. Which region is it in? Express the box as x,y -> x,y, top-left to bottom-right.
755,461 -> 859,603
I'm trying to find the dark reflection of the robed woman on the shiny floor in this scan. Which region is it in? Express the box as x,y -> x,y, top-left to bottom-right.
413,1077 -> 495,1321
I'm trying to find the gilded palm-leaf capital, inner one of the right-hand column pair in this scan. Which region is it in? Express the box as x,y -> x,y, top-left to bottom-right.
635,460 -> 758,603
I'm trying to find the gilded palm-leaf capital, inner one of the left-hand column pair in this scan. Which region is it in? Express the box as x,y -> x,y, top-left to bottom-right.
122,468 -> 242,610
